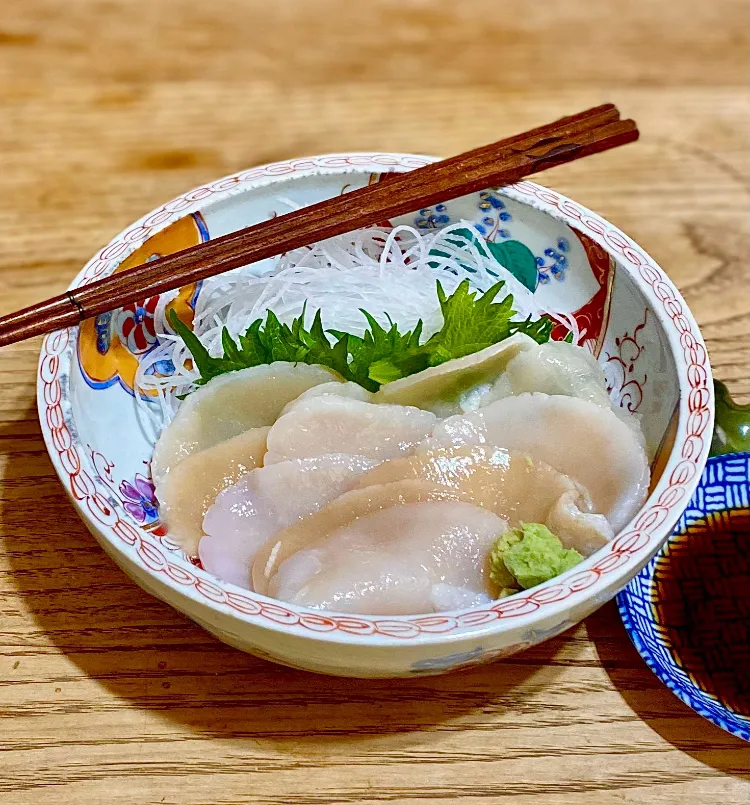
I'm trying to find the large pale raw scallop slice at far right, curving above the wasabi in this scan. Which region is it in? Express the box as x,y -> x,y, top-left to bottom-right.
429,394 -> 649,532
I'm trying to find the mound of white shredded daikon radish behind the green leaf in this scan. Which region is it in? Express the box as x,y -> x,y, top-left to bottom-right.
136,221 -> 548,434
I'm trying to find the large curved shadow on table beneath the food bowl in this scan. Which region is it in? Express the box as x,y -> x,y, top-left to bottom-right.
0,410 -> 567,747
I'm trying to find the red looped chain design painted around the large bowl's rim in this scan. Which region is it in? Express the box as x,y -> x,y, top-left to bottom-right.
39,154 -> 711,639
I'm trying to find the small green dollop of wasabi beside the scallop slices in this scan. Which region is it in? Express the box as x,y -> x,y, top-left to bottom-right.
490,523 -> 583,596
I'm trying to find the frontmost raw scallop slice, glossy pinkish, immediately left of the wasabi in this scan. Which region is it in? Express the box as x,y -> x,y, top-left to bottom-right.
269,501 -> 507,615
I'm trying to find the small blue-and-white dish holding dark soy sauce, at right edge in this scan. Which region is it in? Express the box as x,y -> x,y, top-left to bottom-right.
617,453 -> 750,741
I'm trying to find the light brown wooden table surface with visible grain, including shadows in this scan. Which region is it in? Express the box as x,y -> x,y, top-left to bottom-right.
0,0 -> 750,805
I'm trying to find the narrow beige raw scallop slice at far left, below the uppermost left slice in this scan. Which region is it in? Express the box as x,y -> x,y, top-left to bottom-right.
156,428 -> 269,556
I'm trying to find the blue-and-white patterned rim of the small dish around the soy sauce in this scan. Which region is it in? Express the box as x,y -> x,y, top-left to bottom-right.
617,453 -> 750,741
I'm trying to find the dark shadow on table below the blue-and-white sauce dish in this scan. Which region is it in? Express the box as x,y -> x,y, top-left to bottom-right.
586,602 -> 750,779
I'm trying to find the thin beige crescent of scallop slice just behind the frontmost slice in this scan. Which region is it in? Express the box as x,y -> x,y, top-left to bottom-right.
252,480 -> 471,594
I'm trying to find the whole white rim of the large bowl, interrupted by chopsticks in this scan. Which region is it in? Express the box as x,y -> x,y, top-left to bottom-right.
37,152 -> 714,645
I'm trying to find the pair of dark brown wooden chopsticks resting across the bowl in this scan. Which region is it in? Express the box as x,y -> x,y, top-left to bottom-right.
0,104 -> 638,346
